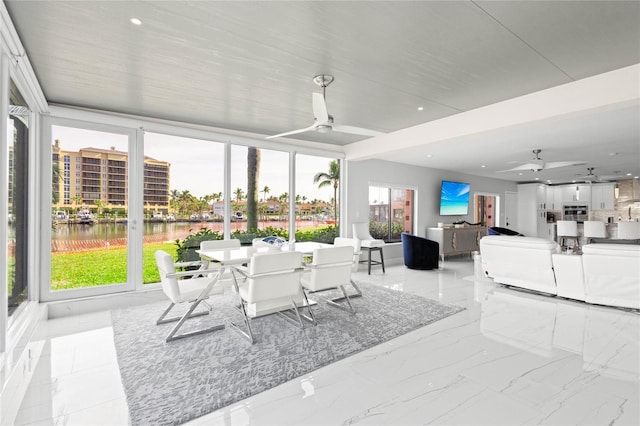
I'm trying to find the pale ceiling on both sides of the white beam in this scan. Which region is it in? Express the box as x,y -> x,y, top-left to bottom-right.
4,1 -> 640,182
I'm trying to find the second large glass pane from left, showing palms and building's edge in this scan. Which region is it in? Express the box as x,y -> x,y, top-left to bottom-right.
142,132 -> 224,284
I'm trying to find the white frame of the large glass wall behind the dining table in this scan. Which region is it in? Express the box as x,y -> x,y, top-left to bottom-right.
38,106 -> 346,301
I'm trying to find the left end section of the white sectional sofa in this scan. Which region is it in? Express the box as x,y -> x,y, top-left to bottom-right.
480,235 -> 560,295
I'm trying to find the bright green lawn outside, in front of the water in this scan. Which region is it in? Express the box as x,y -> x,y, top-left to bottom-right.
51,242 -> 177,290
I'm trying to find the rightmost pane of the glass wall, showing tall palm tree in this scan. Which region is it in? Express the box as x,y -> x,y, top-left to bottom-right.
296,154 -> 340,243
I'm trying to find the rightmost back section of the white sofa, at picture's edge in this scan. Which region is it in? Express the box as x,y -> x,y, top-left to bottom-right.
582,244 -> 640,309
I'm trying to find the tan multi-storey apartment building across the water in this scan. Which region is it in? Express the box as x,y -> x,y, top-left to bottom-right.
52,140 -> 171,214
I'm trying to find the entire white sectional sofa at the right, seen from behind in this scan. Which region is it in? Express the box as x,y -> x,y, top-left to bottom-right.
480,235 -> 640,309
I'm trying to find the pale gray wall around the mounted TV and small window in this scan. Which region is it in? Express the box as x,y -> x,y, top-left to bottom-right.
346,160 -> 517,237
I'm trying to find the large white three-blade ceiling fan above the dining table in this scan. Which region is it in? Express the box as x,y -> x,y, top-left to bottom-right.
266,74 -> 384,139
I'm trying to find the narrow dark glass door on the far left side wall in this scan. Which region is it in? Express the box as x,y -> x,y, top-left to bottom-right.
2,81 -> 30,317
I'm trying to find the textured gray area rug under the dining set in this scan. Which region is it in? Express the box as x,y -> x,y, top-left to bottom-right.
112,283 -> 464,425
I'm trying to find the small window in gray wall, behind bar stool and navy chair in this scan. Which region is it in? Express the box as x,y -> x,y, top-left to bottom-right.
369,185 -> 414,242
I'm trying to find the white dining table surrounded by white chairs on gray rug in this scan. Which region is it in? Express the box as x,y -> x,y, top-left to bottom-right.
196,241 -> 332,317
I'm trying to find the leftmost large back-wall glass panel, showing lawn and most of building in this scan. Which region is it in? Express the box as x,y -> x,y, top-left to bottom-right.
48,124 -> 135,298
